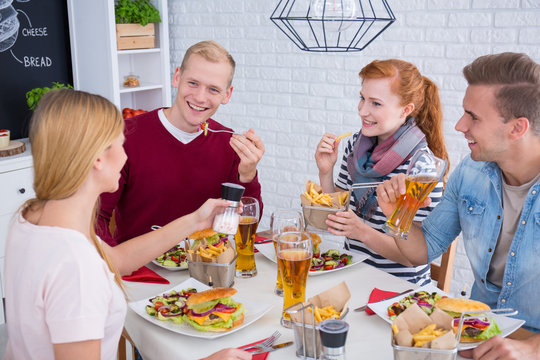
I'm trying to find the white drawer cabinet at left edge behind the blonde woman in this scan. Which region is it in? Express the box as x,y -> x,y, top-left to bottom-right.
0,140 -> 34,324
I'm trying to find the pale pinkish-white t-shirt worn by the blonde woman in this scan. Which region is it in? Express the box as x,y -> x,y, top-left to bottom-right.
4,214 -> 126,360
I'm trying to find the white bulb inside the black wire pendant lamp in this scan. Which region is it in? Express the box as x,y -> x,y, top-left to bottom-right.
310,0 -> 358,32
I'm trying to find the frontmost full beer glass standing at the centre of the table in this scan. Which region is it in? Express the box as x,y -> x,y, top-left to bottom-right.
277,231 -> 313,327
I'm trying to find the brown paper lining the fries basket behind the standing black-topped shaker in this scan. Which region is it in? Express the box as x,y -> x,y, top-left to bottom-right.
291,282 -> 351,325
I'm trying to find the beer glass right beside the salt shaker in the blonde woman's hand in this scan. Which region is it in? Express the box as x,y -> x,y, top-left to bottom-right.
234,197 -> 259,277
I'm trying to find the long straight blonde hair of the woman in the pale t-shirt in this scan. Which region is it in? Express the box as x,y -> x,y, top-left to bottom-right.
22,89 -> 125,293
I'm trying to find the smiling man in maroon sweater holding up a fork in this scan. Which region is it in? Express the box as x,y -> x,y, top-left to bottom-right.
96,41 -> 264,246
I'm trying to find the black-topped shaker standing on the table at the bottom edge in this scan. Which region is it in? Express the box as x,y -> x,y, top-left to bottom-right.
318,319 -> 349,360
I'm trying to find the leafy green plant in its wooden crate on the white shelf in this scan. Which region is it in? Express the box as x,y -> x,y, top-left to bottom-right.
114,0 -> 161,50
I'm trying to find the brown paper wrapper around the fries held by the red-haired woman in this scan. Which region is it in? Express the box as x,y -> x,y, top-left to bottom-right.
300,180 -> 350,230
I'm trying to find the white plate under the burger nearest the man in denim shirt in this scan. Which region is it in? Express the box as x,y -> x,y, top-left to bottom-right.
368,283 -> 525,350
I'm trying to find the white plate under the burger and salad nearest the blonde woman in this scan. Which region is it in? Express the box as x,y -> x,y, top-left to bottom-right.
129,278 -> 272,339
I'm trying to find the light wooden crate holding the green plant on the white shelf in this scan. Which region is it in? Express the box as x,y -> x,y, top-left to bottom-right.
116,23 -> 156,50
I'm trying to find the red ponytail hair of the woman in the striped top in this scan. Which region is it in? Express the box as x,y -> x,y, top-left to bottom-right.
358,59 -> 450,183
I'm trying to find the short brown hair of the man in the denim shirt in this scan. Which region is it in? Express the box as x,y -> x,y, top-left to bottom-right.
463,52 -> 540,136
